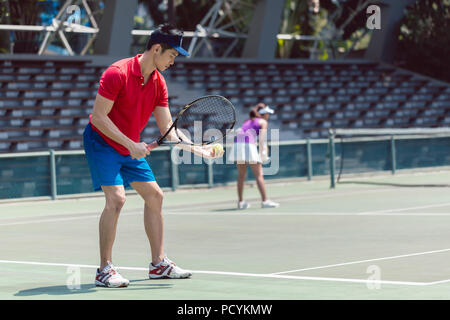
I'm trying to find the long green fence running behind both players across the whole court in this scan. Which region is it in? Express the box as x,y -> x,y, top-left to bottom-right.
0,137 -> 450,199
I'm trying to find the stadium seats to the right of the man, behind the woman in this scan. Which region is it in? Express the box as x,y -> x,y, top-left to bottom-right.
171,61 -> 450,138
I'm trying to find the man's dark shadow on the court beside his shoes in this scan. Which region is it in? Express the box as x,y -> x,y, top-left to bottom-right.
14,279 -> 173,297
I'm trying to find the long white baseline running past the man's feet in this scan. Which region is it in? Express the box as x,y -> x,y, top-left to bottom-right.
0,260 -> 428,286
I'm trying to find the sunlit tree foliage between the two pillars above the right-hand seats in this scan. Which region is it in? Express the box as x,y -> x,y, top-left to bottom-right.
278,0 -> 377,60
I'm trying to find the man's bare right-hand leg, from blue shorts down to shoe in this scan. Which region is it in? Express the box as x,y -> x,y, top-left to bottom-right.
130,181 -> 164,265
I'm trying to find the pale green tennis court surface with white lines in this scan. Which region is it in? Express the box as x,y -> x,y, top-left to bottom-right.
0,170 -> 450,300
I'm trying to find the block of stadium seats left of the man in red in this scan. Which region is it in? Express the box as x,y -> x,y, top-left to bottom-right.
0,59 -> 102,152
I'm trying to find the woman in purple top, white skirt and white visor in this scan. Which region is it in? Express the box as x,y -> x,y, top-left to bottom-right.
230,103 -> 279,209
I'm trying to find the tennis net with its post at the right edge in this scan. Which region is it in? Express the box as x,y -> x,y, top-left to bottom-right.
329,128 -> 450,188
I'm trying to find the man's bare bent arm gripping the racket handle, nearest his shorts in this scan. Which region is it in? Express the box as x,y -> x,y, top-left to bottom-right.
91,94 -> 150,159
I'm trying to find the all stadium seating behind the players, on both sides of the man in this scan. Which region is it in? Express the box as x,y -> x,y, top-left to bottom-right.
0,59 -> 450,152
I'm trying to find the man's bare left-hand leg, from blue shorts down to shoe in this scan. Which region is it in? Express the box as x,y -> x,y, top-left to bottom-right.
99,185 -> 125,270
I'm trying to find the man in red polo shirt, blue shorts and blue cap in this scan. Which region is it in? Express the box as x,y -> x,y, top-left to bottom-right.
83,25 -> 221,287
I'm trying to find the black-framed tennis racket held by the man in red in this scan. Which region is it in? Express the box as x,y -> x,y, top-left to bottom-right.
147,95 -> 236,150
